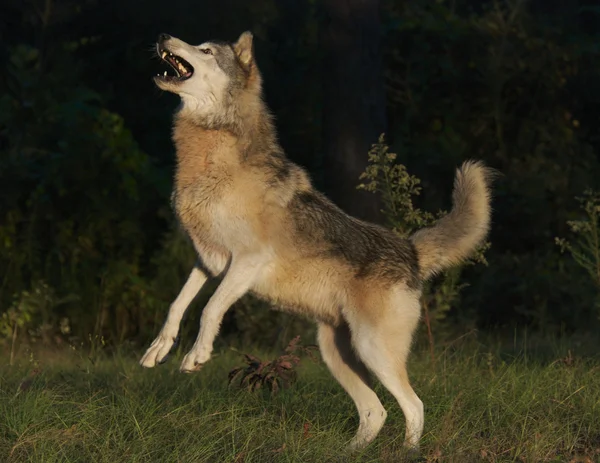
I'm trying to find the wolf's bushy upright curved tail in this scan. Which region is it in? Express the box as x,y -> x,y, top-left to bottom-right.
410,161 -> 493,280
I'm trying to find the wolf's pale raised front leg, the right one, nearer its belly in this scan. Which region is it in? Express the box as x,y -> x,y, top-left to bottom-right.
180,255 -> 266,373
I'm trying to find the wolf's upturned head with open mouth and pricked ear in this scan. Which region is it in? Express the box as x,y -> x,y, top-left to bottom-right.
154,32 -> 261,125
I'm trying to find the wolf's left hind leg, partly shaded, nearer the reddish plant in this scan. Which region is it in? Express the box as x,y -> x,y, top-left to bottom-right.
318,323 -> 387,449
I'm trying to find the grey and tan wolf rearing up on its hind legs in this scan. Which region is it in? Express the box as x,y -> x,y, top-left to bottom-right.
140,33 -> 490,454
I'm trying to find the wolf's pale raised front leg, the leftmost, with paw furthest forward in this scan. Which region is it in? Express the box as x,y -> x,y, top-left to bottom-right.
140,265 -> 207,368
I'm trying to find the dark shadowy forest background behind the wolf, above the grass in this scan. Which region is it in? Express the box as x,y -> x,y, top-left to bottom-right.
0,0 -> 600,356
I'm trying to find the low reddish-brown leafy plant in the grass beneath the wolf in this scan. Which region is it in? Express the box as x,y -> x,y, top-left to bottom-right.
229,336 -> 315,394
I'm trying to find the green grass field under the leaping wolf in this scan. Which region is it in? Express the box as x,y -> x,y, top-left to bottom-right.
0,341 -> 600,463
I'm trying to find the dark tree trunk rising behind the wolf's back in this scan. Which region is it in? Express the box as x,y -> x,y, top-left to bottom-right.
320,0 -> 386,221
